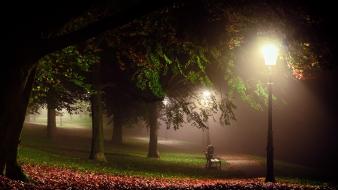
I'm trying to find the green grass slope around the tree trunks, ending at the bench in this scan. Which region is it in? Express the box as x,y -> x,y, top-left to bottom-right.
18,124 -> 233,178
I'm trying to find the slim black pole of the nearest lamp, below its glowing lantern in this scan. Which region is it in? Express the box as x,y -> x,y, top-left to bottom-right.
265,66 -> 275,182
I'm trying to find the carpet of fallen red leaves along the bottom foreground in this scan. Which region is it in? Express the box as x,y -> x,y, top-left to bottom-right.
0,164 -> 334,190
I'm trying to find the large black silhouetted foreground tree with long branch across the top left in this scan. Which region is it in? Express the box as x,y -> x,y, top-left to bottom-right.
0,1 -> 177,180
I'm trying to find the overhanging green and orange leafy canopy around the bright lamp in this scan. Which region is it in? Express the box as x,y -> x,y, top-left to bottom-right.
42,0 -> 325,131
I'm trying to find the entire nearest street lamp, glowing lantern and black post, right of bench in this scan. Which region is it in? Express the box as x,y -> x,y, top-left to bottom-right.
262,44 -> 278,182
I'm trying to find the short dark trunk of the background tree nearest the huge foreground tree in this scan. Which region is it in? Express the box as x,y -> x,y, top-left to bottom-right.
47,90 -> 56,138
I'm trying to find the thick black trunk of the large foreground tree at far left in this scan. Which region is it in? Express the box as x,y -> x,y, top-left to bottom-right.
0,67 -> 36,181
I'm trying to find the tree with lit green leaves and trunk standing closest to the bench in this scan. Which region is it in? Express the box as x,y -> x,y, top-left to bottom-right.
97,12 -> 208,157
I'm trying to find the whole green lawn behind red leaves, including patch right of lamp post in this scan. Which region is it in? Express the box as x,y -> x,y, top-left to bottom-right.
18,125 -> 336,187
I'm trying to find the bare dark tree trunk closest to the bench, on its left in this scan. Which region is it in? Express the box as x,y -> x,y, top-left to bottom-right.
148,103 -> 160,158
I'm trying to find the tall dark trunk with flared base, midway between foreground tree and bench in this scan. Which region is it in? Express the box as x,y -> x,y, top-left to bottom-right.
89,64 -> 106,162
